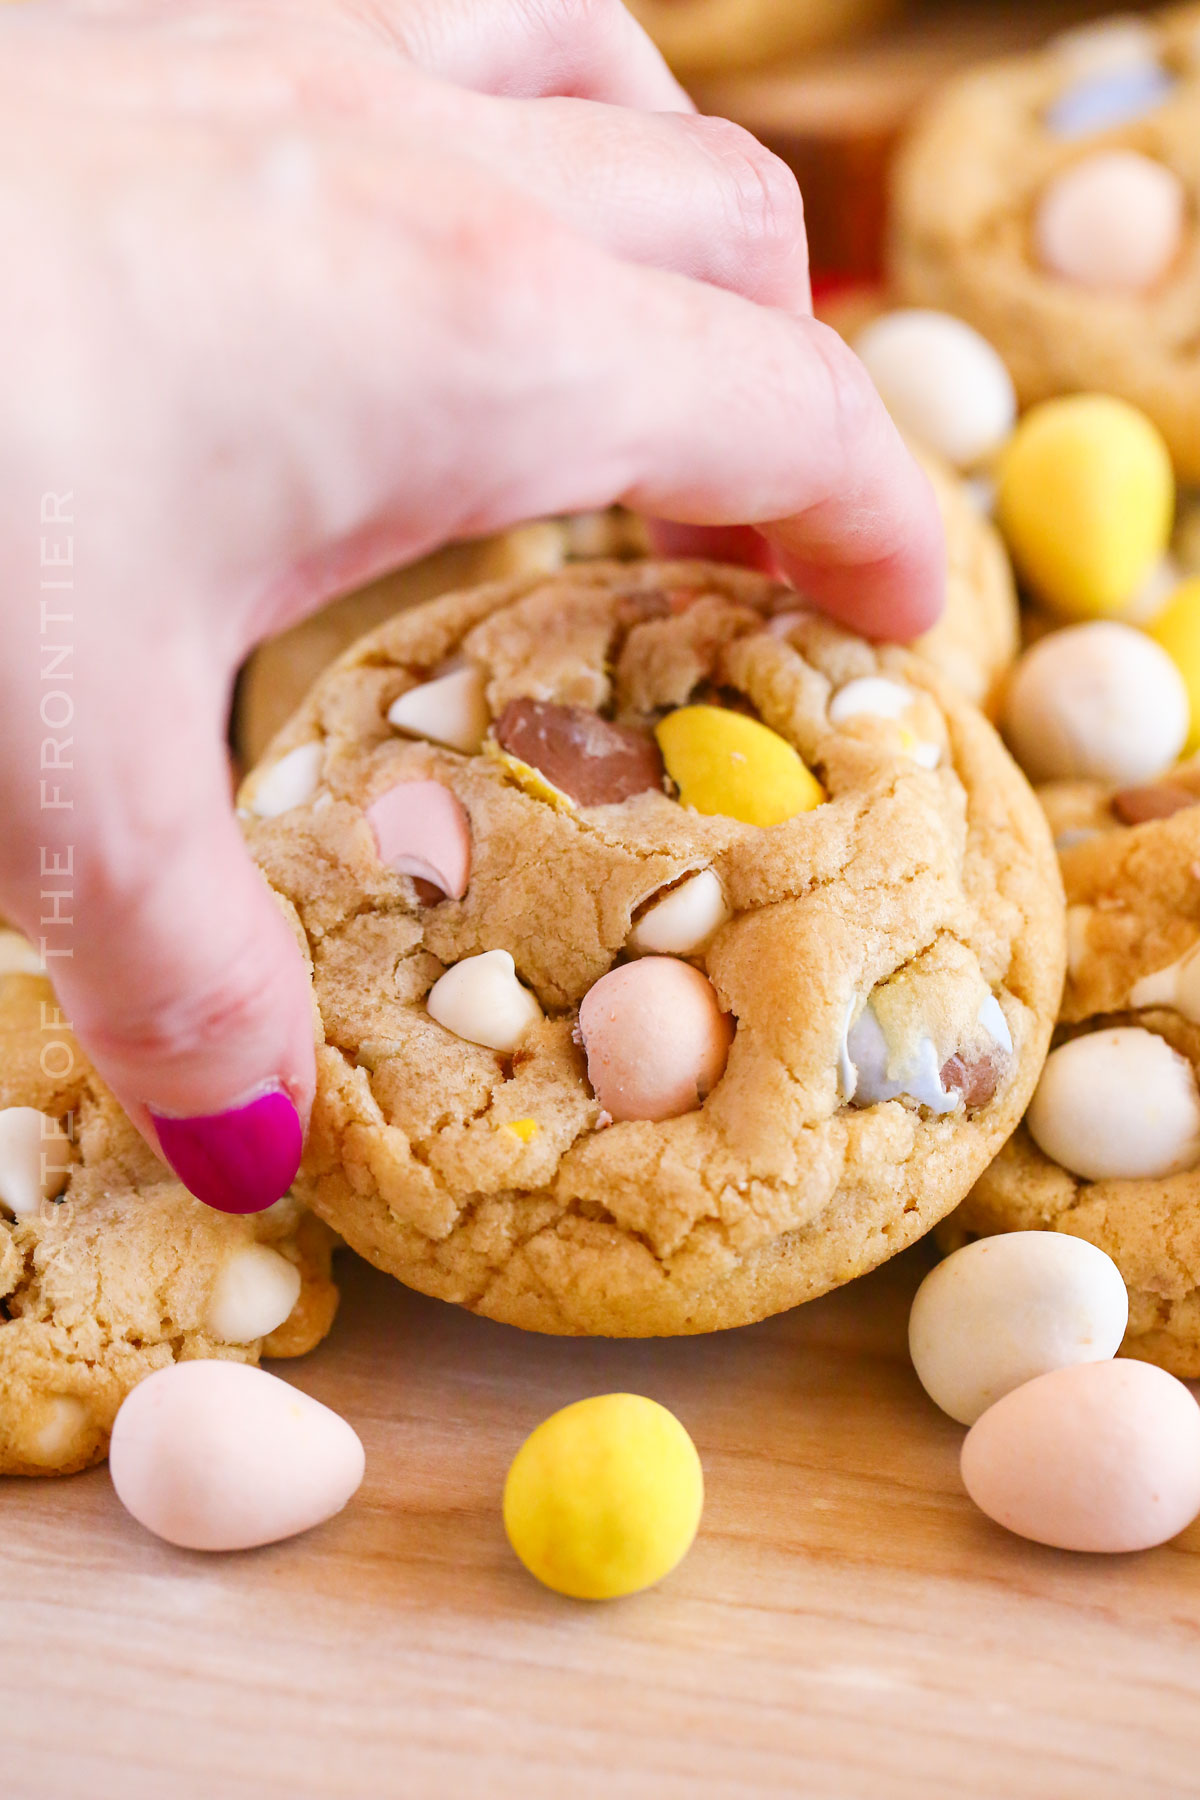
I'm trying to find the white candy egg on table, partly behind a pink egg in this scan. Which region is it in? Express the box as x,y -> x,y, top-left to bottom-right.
909,1231 -> 1130,1426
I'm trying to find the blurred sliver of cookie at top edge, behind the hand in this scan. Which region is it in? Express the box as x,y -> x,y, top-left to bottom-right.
630,0 -> 896,76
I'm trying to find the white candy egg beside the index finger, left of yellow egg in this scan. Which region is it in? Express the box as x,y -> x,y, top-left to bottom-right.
855,308 -> 1016,468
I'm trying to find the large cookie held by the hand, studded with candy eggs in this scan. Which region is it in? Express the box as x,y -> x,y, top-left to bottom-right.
241,563 -> 1063,1336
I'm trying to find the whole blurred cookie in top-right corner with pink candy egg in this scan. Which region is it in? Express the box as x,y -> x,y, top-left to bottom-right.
889,5 -> 1200,481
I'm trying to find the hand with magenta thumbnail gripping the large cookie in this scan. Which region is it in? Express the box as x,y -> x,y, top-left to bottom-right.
0,0 -> 941,1210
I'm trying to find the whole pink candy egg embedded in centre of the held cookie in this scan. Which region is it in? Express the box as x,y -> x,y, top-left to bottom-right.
579,956 -> 734,1120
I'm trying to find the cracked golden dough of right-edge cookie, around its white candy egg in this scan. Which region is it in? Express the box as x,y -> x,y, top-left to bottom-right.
937,795 -> 1200,1379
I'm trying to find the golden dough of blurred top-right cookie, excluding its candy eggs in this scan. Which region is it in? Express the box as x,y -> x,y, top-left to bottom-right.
889,5 -> 1200,481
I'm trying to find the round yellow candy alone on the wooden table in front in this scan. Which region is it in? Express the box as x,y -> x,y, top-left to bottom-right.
504,1393 -> 703,1600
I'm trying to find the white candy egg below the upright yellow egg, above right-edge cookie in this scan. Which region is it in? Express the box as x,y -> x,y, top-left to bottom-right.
1002,619 -> 1191,785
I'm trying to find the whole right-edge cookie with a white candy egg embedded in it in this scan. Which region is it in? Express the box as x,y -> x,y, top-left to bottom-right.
937,792 -> 1200,1379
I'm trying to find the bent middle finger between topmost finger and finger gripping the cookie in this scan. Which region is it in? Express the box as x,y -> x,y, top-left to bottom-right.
462,101 -> 811,311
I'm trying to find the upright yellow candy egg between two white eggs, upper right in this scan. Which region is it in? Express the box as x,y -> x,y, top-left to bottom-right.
997,394 -> 1175,619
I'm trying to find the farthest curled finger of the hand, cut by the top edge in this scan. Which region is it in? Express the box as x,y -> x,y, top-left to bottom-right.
351,0 -> 691,112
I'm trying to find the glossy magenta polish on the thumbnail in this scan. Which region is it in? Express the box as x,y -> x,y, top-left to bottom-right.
149,1087 -> 304,1213
